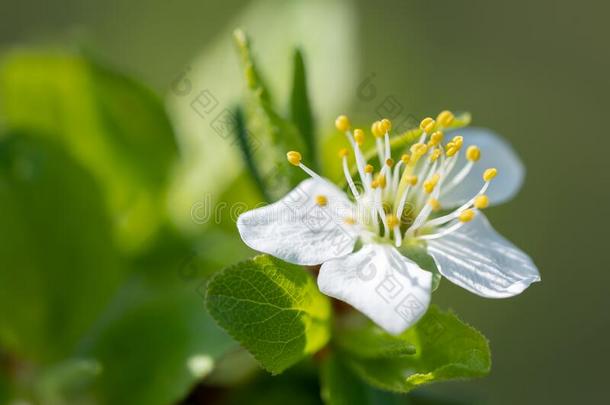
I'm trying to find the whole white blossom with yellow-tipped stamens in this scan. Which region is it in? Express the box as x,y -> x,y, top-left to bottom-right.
237,111 -> 540,334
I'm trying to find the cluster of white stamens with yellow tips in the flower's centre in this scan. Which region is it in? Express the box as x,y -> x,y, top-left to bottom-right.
287,111 -> 497,247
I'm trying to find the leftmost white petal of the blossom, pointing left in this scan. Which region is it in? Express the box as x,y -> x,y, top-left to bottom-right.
237,179 -> 356,265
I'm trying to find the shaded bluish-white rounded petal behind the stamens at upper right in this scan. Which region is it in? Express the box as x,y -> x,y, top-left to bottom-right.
441,128 -> 525,208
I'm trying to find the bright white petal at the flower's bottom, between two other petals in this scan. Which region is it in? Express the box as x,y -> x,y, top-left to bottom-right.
318,244 -> 432,334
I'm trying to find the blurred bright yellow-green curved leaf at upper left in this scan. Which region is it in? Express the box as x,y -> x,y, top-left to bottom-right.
0,50 -> 176,251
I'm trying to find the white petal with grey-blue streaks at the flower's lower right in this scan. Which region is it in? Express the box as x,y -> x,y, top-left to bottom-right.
428,212 -> 540,298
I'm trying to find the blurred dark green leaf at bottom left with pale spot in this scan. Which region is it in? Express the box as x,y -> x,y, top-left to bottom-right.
79,233 -> 238,405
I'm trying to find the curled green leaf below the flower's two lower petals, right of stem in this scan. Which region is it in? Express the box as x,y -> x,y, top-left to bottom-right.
348,306 -> 491,392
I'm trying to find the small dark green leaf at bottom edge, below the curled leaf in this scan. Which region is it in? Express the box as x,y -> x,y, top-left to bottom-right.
320,354 -> 371,405
